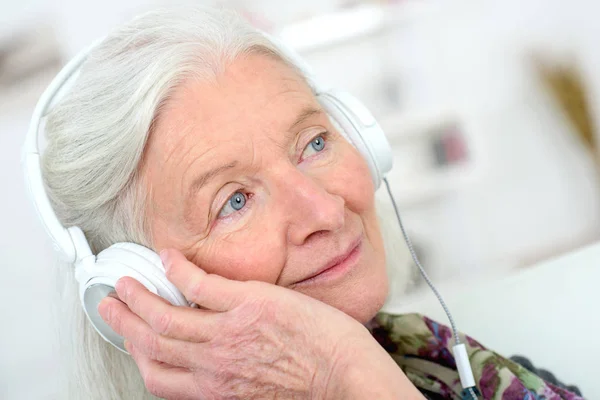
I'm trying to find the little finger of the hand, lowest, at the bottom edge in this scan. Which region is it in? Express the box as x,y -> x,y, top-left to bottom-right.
125,342 -> 200,399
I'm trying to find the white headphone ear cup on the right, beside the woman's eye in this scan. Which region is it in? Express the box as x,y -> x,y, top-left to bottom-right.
317,91 -> 393,189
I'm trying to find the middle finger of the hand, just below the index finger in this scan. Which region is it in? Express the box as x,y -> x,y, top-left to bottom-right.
116,277 -> 221,342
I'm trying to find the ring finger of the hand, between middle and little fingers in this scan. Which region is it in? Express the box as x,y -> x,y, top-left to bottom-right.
98,297 -> 193,367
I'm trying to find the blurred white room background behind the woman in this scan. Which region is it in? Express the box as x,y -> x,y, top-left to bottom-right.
0,0 -> 600,399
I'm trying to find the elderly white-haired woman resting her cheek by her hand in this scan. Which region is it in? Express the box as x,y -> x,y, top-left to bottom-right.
43,9 -> 576,400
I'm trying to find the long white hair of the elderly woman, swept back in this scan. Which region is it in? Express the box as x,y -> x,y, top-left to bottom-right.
42,7 -> 408,400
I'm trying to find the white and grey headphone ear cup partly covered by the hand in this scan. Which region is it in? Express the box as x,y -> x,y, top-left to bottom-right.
79,243 -> 190,351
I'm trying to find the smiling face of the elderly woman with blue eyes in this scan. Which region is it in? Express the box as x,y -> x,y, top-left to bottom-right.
141,55 -> 387,322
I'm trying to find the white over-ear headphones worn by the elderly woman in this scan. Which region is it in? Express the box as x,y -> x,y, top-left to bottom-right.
22,34 -> 392,352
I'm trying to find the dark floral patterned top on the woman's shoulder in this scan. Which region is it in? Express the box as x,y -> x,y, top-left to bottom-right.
370,313 -> 583,400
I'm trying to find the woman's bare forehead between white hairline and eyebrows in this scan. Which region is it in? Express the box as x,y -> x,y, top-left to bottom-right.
154,55 -> 320,151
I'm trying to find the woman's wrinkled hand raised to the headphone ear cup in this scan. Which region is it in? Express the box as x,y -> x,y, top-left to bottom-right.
99,250 -> 418,399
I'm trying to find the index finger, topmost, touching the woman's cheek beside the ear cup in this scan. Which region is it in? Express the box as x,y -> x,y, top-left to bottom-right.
160,249 -> 245,311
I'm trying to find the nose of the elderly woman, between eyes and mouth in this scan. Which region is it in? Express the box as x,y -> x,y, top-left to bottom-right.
280,170 -> 345,246
